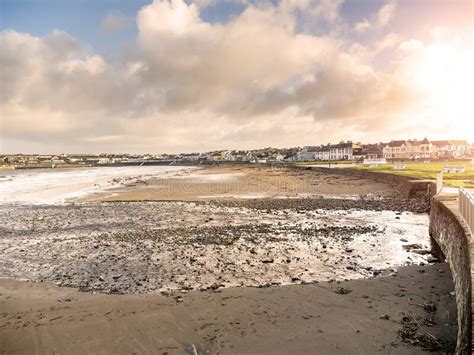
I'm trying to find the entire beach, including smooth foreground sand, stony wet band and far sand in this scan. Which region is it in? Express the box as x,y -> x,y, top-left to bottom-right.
0,166 -> 456,354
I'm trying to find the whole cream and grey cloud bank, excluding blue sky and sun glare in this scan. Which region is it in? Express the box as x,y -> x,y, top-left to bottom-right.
0,0 -> 468,152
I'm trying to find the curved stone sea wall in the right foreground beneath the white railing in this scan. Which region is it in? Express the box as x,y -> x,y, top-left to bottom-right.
430,194 -> 474,354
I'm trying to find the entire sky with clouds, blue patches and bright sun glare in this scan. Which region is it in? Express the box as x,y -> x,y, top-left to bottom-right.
0,0 -> 474,153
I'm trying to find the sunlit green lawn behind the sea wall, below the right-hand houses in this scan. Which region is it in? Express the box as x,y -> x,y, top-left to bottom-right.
356,162 -> 474,188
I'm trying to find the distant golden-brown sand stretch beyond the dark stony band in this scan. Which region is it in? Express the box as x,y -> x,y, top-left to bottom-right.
85,166 -> 397,201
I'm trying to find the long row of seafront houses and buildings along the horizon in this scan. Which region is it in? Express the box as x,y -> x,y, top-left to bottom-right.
0,138 -> 474,165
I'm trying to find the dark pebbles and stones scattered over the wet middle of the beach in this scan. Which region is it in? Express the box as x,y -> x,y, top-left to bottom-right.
0,198 -> 430,295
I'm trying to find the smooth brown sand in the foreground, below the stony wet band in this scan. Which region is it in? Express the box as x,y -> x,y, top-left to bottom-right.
0,264 -> 456,354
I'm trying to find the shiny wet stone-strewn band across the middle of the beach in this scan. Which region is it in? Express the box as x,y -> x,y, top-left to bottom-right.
0,199 -> 435,294
